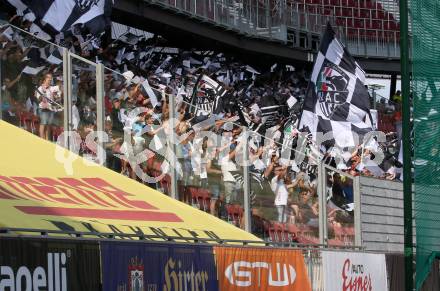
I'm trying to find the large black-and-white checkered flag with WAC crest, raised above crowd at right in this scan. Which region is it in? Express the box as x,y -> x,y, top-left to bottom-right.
299,24 -> 372,147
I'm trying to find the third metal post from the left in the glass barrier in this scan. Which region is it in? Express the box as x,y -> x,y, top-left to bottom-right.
168,95 -> 177,200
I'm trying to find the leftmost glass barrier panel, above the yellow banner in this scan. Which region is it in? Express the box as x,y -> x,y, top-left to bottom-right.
0,26 -> 64,141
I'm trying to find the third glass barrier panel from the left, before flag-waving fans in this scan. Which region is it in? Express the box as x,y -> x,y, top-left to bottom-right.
104,68 -> 171,194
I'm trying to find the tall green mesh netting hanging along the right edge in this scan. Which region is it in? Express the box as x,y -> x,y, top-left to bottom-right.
410,0 -> 440,290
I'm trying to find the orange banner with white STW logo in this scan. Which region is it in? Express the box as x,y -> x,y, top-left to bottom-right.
214,247 -> 312,291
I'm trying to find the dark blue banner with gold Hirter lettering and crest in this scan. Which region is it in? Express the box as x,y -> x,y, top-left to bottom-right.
101,242 -> 219,291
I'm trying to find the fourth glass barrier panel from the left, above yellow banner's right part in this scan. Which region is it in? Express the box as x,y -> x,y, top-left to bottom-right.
176,101 -> 248,228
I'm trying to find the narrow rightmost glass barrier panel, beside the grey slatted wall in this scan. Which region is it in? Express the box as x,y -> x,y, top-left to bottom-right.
324,166 -> 355,246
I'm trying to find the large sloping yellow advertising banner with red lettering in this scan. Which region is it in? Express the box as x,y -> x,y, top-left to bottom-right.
0,121 -> 259,240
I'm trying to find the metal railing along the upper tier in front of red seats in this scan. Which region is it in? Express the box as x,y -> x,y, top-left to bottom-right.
144,0 -> 400,58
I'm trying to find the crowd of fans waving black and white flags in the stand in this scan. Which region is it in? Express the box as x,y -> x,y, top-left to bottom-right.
0,17 -> 401,239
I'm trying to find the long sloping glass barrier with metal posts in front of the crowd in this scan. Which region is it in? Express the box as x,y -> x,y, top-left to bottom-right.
0,26 -> 404,252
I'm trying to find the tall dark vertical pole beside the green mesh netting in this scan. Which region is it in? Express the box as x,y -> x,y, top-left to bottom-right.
399,0 -> 414,291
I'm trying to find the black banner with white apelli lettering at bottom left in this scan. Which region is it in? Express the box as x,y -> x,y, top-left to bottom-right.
0,237 -> 101,291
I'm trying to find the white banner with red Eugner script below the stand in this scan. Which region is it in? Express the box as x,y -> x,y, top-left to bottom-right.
322,251 -> 388,291
